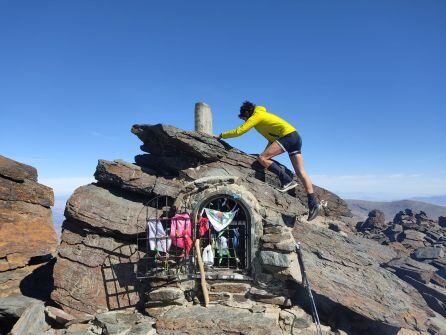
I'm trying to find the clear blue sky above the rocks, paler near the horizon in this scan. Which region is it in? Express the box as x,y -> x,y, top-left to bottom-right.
0,0 -> 446,199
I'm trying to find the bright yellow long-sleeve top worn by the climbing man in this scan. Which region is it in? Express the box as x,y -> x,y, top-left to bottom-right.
221,106 -> 296,143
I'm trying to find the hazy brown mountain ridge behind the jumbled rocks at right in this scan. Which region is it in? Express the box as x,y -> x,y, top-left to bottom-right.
344,199 -> 446,221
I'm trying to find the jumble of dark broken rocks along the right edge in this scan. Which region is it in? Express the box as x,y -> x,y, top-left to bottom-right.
356,209 -> 446,330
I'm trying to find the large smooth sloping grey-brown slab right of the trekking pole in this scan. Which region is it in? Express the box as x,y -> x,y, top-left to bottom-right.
293,222 -> 430,334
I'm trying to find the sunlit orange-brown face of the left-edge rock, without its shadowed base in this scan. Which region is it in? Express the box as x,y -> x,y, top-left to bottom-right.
0,156 -> 57,297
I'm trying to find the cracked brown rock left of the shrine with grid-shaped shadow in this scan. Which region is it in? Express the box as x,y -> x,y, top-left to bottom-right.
52,185 -> 149,316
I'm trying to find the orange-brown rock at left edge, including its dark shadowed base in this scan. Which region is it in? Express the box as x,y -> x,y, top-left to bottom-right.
0,156 -> 57,332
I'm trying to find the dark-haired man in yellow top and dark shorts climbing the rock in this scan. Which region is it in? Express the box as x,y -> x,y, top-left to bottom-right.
214,101 -> 320,221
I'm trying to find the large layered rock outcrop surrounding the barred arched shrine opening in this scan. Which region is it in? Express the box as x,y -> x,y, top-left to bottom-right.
52,125 -> 440,334
